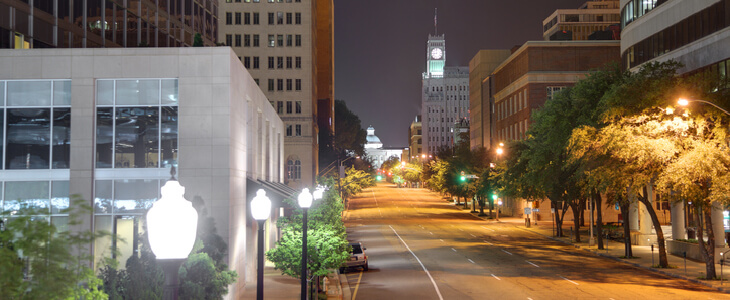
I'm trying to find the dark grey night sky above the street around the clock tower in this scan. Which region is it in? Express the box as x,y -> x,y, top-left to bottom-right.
334,0 -> 586,147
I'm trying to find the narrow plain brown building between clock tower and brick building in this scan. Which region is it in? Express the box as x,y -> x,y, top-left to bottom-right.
469,50 -> 511,150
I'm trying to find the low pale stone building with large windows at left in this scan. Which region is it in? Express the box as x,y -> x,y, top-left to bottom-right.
0,47 -> 284,299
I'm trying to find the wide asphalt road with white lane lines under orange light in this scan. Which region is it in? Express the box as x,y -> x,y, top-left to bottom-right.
346,184 -> 730,300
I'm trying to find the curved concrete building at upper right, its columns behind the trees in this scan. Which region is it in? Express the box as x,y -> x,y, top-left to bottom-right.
621,0 -> 730,259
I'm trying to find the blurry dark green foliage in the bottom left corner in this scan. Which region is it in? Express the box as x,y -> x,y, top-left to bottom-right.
0,195 -> 108,299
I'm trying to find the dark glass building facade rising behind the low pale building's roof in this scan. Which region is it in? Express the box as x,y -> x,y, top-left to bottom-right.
0,0 -> 218,49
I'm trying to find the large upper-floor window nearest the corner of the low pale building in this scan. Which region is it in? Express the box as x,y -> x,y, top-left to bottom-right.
96,79 -> 178,168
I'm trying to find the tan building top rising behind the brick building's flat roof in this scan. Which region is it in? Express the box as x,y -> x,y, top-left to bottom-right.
542,0 -> 620,41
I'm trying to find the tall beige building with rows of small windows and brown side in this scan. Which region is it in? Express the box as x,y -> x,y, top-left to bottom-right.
218,0 -> 334,188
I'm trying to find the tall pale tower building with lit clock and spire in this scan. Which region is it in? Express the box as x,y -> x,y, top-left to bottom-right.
421,34 -> 469,154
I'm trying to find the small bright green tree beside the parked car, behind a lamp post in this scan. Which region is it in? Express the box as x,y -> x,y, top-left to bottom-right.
266,185 -> 348,278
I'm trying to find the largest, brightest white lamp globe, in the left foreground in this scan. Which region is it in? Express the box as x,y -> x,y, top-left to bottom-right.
147,180 -> 198,259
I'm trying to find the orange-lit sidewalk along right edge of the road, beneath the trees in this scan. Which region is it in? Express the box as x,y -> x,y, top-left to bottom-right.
462,209 -> 730,293
